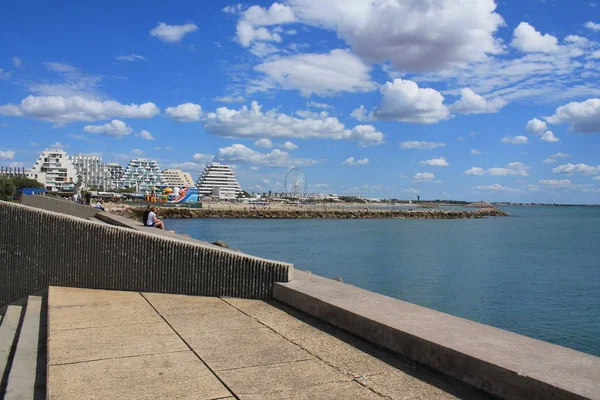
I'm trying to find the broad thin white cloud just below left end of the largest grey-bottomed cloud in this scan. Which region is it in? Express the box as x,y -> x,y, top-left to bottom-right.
250,49 -> 376,96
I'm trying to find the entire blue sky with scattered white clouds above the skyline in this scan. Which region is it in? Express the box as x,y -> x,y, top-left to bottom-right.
0,0 -> 600,203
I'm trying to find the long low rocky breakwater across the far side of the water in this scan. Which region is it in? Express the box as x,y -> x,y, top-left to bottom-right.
110,207 -> 508,220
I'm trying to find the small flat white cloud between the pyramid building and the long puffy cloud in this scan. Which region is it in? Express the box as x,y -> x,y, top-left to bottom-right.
217,144 -> 319,168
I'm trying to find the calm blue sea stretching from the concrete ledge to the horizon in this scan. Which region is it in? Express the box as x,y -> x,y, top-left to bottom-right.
166,207 -> 600,356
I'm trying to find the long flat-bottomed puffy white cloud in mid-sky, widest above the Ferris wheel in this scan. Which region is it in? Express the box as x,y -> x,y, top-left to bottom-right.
204,101 -> 384,146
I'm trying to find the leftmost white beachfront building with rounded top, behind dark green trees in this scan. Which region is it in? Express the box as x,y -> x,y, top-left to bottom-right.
27,149 -> 77,193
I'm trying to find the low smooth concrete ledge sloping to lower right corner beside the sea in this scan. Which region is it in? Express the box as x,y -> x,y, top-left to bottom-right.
273,271 -> 600,400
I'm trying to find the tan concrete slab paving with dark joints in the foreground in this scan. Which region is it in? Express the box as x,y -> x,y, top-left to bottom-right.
48,287 -> 483,400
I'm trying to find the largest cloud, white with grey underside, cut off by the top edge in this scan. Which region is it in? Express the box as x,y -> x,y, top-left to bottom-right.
287,0 -> 504,71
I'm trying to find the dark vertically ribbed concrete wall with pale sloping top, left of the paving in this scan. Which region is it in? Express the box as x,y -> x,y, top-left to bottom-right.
0,202 -> 294,307
